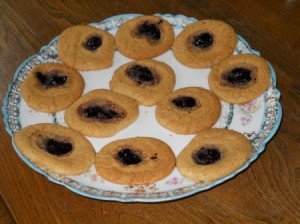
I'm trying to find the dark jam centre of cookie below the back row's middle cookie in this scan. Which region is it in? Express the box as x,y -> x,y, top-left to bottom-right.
126,65 -> 157,85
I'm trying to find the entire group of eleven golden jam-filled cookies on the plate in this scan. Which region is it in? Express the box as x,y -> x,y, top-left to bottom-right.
14,16 -> 270,184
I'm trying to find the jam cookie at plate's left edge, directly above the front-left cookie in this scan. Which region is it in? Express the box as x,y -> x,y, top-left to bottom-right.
20,63 -> 85,113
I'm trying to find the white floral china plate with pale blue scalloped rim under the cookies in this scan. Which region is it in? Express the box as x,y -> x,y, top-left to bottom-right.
2,14 -> 282,202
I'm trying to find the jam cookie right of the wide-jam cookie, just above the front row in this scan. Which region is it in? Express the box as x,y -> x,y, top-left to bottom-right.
155,87 -> 221,134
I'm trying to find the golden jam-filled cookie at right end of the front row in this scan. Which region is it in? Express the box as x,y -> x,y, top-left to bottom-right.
176,128 -> 253,182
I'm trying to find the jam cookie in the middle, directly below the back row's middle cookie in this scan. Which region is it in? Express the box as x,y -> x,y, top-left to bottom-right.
109,59 -> 176,106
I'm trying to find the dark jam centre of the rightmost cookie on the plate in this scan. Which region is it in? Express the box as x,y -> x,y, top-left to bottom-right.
223,68 -> 252,85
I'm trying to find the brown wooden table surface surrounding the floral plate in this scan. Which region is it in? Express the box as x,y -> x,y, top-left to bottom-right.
0,0 -> 300,224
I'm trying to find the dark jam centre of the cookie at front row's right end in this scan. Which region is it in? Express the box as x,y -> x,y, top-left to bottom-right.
193,147 -> 221,165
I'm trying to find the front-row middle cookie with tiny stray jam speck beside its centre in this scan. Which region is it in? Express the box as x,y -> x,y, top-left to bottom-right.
95,137 -> 176,185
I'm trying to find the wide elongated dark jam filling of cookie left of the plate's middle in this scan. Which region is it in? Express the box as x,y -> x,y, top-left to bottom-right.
82,104 -> 122,120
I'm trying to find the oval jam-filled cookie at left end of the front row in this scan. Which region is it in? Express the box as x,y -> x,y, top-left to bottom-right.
14,123 -> 96,175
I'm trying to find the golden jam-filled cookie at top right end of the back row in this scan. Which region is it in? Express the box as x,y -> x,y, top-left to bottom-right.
172,20 -> 238,68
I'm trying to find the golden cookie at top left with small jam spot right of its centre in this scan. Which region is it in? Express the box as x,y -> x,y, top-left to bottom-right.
57,25 -> 115,70
